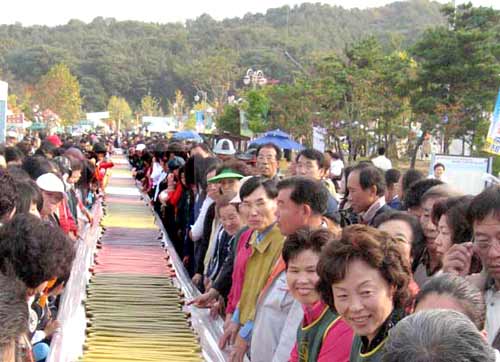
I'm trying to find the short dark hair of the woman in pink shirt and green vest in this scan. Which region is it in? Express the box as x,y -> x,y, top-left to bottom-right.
281,226 -> 334,268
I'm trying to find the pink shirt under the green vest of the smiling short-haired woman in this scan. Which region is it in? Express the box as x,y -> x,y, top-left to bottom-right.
289,300 -> 354,362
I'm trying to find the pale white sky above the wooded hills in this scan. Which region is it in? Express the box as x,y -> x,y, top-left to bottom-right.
0,0 -> 500,26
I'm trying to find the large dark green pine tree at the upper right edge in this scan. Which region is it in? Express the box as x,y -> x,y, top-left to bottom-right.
412,4 -> 500,156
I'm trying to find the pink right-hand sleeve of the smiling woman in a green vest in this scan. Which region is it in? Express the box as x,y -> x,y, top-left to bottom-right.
317,320 -> 354,362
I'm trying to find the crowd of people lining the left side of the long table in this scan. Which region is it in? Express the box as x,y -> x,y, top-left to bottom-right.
0,132 -> 113,362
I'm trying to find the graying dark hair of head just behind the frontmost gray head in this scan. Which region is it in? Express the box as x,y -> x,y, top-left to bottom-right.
415,274 -> 486,331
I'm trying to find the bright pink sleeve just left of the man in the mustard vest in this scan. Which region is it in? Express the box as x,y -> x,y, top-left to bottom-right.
226,229 -> 253,313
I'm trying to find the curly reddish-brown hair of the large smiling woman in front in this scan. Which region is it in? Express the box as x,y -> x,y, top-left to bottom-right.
318,225 -> 411,310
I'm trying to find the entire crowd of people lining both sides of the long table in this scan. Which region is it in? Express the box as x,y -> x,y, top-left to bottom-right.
0,130 -> 500,362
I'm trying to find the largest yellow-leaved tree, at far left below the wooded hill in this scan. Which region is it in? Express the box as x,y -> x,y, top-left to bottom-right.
34,64 -> 82,124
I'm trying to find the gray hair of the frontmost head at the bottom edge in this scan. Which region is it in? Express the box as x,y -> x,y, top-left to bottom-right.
382,309 -> 495,362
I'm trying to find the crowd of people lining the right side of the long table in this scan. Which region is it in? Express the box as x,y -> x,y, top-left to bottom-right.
128,139 -> 500,362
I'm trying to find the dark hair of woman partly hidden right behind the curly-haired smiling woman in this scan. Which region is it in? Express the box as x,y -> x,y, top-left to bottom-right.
374,211 -> 426,272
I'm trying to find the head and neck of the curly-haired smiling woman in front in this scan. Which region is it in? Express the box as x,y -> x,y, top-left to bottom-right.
318,225 -> 411,362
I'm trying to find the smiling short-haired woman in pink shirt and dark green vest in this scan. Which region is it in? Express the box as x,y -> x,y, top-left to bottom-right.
282,228 -> 353,362
